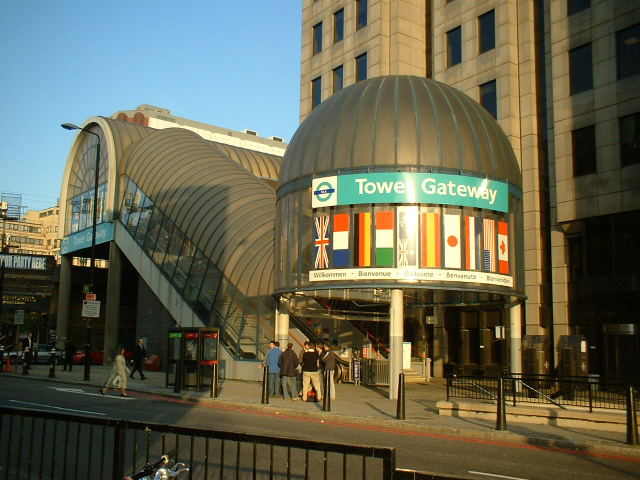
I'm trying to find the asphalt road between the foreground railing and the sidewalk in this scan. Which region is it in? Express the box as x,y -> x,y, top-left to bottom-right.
0,377 -> 640,480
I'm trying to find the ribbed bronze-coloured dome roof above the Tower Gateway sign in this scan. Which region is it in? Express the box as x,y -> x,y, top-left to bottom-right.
279,75 -> 522,188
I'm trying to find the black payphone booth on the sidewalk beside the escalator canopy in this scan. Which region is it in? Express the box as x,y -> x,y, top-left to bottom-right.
165,328 -> 219,390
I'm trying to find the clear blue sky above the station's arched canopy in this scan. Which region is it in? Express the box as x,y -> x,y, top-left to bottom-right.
0,0 -> 301,209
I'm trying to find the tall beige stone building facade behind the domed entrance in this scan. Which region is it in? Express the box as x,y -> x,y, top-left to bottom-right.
300,0 -> 640,378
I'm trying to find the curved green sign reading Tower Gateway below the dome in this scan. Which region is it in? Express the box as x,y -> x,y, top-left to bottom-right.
312,172 -> 509,212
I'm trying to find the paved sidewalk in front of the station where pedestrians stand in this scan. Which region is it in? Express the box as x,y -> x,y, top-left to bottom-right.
5,365 -> 640,458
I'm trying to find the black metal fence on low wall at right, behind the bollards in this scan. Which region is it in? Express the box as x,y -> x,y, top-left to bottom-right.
447,374 -> 640,411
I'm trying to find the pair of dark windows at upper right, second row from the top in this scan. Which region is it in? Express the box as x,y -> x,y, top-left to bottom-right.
569,24 -> 640,95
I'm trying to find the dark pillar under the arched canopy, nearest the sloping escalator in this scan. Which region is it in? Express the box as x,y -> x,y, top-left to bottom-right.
104,242 -> 122,365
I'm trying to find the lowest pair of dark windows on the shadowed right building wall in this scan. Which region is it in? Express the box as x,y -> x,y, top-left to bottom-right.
571,113 -> 640,177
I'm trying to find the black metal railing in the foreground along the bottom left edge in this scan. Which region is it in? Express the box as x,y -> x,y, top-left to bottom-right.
0,407 -> 400,480
